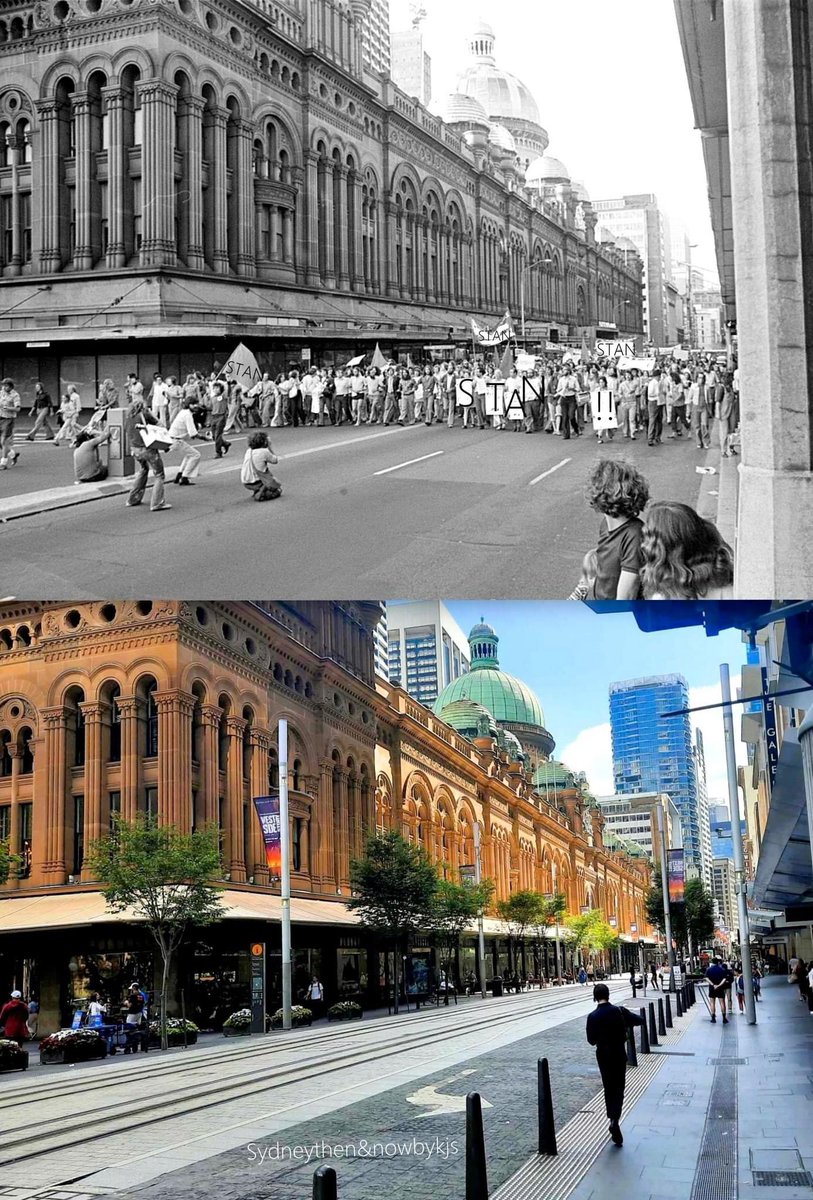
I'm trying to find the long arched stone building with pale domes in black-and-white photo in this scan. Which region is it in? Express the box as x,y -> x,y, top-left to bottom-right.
0,0 -> 642,391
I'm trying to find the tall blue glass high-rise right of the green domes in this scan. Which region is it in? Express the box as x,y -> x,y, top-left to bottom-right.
609,674 -> 703,877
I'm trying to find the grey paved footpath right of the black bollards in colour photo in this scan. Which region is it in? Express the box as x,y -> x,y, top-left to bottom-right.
495,978 -> 813,1200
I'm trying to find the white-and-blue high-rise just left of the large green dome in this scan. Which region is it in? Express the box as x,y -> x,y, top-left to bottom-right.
387,600 -> 470,707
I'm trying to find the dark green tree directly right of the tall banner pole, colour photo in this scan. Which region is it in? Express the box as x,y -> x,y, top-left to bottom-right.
347,829 -> 440,1013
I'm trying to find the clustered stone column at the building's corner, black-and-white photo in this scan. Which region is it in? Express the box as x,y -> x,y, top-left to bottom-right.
136,79 -> 177,266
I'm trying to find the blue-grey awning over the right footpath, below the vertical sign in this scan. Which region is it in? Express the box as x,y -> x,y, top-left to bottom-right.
753,730 -> 813,908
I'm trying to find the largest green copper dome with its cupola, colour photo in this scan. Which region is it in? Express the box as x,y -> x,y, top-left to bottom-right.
433,622 -> 544,728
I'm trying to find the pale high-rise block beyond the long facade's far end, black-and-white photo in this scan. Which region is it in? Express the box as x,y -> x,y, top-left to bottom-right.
592,192 -> 672,346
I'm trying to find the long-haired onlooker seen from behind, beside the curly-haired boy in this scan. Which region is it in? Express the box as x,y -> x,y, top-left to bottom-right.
640,500 -> 734,600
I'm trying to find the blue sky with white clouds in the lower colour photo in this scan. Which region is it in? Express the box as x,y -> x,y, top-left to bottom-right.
446,600 -> 746,803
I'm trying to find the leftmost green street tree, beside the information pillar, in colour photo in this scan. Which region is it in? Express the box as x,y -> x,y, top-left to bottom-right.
89,814 -> 223,1050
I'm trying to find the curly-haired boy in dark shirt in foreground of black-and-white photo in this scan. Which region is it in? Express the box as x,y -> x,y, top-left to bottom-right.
588,458 -> 649,600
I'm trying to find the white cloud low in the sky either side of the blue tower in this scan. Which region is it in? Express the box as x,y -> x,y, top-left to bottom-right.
556,676 -> 747,803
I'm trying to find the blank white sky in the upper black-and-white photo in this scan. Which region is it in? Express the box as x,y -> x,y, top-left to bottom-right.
390,0 -> 716,283
